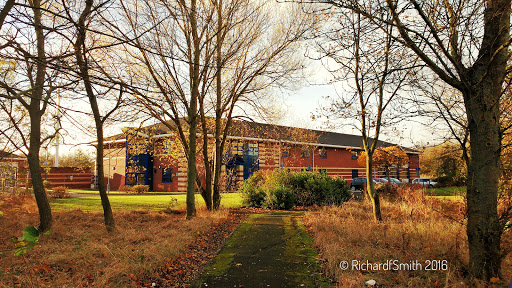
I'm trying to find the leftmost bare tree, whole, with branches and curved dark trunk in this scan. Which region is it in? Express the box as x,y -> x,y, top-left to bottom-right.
0,0 -> 68,232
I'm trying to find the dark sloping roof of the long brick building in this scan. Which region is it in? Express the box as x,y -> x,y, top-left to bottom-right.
106,120 -> 418,153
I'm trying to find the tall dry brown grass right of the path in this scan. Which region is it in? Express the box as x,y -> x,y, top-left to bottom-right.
305,188 -> 512,287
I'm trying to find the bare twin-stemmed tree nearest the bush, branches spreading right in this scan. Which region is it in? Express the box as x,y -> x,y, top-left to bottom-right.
199,0 -> 310,209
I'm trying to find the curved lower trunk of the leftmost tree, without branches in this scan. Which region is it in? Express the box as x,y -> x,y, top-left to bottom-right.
27,111 -> 53,232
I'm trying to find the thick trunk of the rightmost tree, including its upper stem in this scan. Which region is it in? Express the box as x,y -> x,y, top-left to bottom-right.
462,0 -> 511,281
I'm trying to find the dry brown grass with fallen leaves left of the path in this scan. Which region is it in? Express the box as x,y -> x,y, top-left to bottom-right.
0,197 -> 229,287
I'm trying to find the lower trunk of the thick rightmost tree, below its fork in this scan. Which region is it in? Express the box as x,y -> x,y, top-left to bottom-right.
466,85 -> 502,280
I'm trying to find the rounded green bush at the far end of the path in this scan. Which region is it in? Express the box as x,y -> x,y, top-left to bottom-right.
240,169 -> 351,209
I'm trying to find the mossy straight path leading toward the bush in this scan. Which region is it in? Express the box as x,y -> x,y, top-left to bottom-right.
192,211 -> 332,288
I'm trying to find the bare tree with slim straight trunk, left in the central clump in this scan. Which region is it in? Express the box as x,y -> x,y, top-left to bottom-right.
117,0 -> 214,219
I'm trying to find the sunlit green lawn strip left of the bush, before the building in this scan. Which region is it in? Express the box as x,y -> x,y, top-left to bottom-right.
50,189 -> 242,211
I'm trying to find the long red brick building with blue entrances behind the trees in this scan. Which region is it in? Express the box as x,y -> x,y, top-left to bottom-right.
100,121 -> 419,192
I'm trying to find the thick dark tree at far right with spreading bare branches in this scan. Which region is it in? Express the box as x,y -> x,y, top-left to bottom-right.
319,0 -> 511,280
